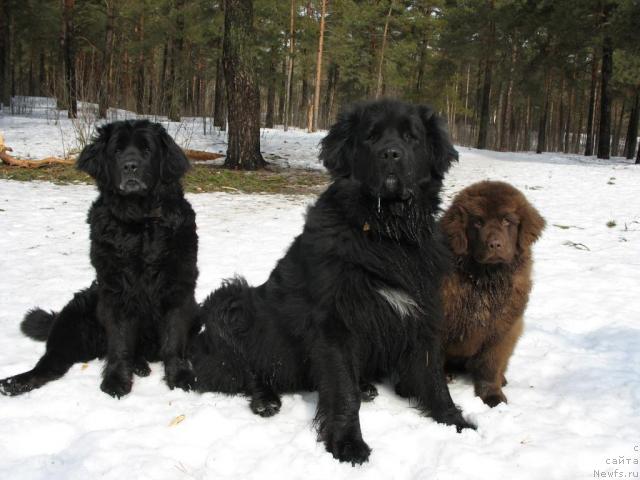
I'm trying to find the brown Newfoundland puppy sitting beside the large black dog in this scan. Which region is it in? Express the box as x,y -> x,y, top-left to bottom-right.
440,181 -> 545,407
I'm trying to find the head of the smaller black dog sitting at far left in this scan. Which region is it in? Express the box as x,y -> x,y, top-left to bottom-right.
76,120 -> 189,196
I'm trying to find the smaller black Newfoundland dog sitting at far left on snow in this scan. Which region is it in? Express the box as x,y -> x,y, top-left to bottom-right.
0,120 -> 198,397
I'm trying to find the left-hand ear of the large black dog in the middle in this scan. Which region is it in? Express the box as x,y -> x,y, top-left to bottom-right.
320,105 -> 360,178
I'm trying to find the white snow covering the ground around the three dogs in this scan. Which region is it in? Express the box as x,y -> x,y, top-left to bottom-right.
0,109 -> 640,480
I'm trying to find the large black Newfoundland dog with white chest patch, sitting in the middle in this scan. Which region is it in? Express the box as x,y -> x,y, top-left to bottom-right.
192,100 -> 472,464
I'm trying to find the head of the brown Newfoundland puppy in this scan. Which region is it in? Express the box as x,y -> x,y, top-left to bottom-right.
440,181 -> 545,264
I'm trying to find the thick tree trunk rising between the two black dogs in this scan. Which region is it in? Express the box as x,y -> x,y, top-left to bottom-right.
222,0 -> 266,170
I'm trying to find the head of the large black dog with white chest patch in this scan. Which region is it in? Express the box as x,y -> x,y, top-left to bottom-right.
320,100 -> 458,201
